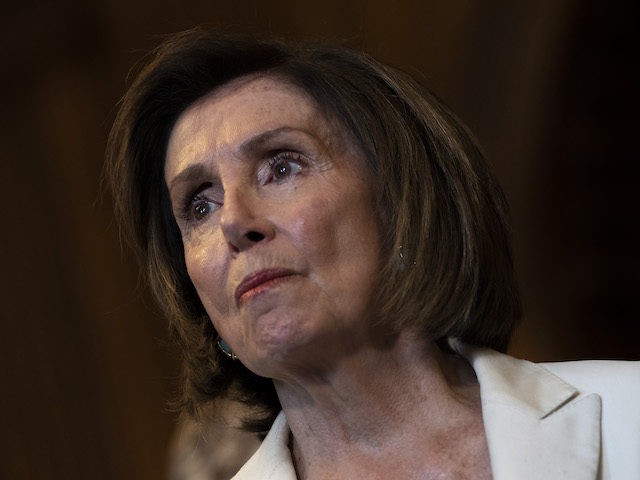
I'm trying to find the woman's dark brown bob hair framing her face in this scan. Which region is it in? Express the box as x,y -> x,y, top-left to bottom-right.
105,28 -> 520,432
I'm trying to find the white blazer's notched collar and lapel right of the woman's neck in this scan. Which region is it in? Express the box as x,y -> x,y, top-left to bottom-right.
451,341 -> 601,480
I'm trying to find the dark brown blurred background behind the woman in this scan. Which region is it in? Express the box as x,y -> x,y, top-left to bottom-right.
0,0 -> 640,480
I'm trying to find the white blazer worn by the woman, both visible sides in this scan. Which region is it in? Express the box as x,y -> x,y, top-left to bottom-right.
232,341 -> 640,480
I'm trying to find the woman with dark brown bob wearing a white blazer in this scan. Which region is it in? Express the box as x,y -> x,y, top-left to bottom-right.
108,30 -> 640,479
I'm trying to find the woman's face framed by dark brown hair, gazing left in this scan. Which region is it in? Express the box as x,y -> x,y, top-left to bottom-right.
165,76 -> 380,378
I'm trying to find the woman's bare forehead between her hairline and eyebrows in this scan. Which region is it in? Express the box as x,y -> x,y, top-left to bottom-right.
165,74 -> 343,178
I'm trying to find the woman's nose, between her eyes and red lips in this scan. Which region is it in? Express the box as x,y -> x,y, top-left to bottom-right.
220,190 -> 275,253
